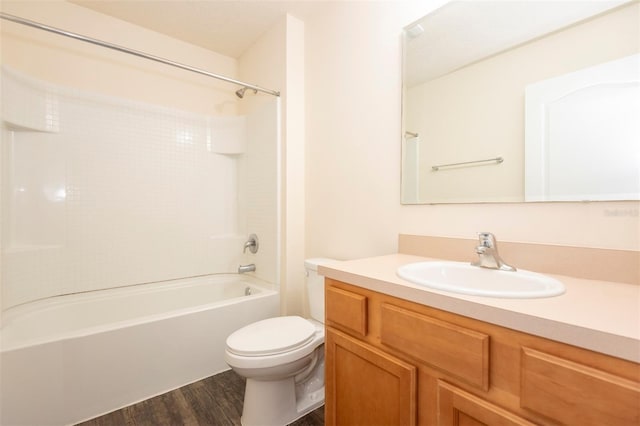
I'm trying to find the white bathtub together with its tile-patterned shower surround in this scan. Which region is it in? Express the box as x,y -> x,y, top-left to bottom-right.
0,68 -> 279,424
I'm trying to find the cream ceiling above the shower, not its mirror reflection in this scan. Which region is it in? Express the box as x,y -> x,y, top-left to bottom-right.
70,0 -> 328,58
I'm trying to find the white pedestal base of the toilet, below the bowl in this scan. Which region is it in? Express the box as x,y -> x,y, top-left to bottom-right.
240,377 -> 324,426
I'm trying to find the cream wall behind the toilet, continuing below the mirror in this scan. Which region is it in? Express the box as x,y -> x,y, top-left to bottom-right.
305,1 -> 640,259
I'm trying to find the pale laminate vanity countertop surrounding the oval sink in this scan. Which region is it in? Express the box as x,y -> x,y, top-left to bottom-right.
318,254 -> 640,362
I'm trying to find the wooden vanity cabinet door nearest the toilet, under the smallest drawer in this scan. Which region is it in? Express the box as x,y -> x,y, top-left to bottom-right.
325,328 -> 416,426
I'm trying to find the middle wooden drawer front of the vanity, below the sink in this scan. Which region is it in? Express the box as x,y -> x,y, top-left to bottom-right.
380,303 -> 489,390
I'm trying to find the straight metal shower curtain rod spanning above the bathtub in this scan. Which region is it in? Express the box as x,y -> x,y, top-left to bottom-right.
0,12 -> 280,96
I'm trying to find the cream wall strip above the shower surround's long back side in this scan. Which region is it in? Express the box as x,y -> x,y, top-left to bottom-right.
0,0 -> 237,114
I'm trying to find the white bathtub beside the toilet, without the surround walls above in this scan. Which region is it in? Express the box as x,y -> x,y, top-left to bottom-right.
0,274 -> 280,425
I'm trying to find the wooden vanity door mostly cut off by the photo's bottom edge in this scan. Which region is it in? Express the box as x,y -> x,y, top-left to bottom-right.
438,380 -> 534,426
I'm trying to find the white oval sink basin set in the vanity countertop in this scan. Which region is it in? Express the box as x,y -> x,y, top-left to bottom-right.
397,262 -> 565,299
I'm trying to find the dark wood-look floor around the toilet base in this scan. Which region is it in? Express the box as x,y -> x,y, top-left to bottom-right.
78,370 -> 324,426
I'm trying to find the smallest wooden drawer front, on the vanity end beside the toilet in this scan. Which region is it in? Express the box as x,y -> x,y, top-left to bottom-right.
325,286 -> 367,337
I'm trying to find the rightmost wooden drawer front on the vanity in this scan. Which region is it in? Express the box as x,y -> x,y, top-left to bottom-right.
520,347 -> 640,426
